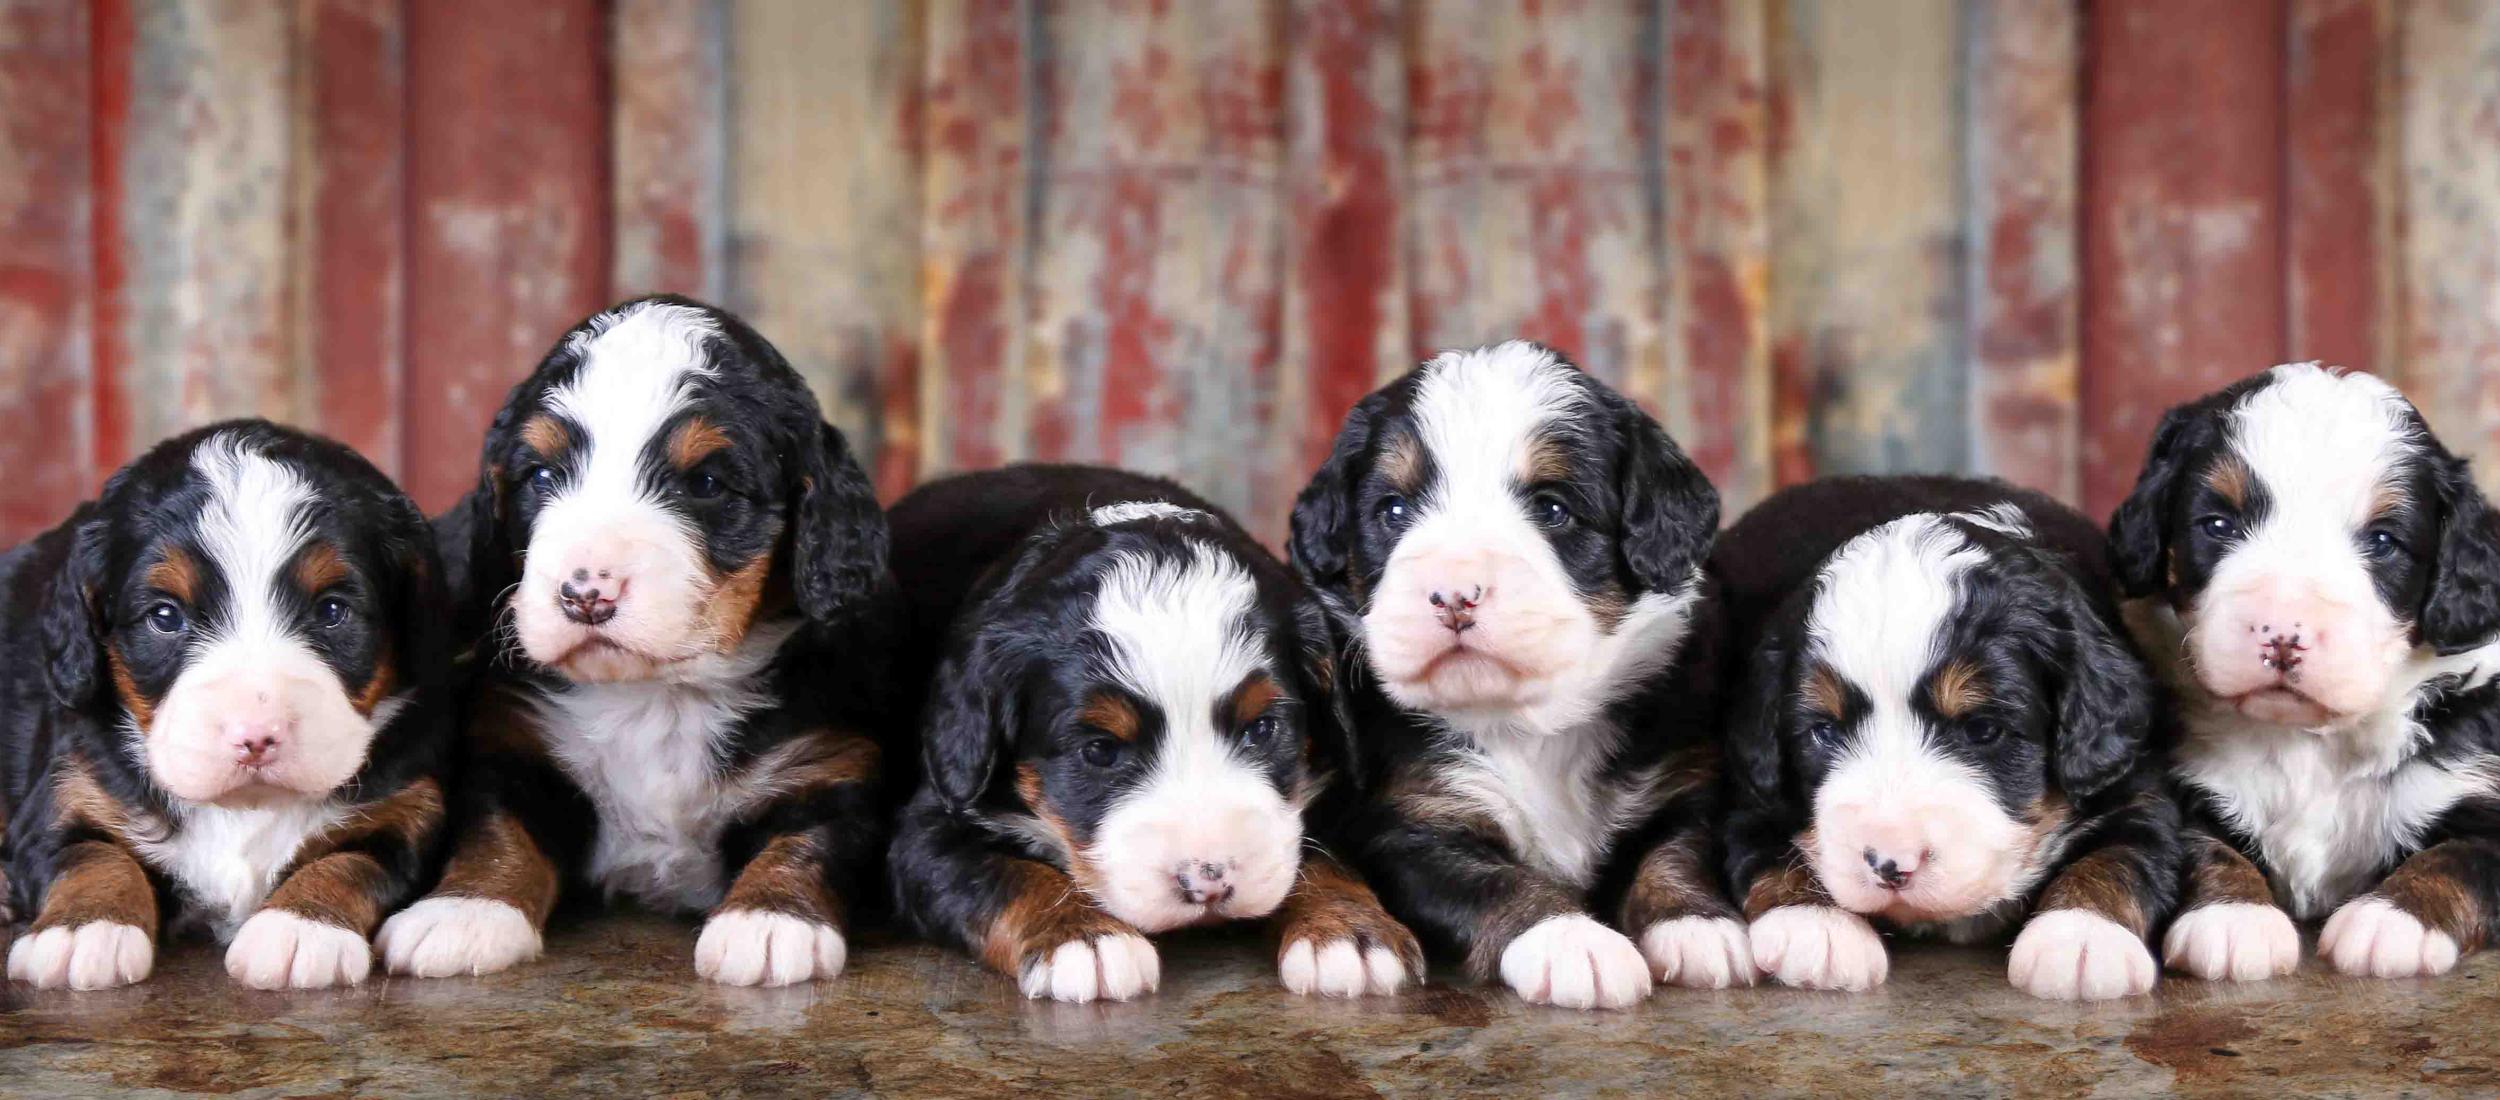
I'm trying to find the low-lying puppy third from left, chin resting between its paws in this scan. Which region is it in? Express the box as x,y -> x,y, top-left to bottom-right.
893,465 -> 1423,1003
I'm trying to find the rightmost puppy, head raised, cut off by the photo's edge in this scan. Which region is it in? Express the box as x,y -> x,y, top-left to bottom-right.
2110,365 -> 2500,980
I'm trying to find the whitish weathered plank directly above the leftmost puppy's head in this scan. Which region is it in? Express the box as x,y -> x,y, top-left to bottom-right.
109,3 -> 310,455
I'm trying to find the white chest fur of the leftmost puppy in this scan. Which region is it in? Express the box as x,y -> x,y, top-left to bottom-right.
133,803 -> 348,940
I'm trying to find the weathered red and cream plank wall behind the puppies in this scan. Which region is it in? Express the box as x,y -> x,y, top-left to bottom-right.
0,0 -> 2500,547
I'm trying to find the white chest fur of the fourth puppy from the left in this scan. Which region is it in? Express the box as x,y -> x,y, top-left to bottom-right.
1450,720 -> 1658,890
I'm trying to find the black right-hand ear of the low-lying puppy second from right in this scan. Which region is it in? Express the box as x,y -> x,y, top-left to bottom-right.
2045,570 -> 2158,798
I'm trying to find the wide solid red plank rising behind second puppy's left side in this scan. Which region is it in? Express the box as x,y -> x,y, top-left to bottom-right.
403,0 -> 610,510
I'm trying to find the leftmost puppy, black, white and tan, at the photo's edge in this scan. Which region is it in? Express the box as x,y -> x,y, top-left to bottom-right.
0,420 -> 450,990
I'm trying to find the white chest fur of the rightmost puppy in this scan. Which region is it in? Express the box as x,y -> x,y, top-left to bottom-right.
2180,723 -> 2495,918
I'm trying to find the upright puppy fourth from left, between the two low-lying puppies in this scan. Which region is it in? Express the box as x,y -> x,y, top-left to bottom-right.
1290,343 -> 1753,1008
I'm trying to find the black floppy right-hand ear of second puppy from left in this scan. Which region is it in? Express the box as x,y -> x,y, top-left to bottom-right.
790,420 -> 893,623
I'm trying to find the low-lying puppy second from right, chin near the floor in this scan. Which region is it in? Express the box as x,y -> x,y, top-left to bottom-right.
1713,478 -> 2180,1000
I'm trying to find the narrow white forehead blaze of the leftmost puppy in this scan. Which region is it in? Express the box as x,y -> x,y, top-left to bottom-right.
190,433 -> 313,648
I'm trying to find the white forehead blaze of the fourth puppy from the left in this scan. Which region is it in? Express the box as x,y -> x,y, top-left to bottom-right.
1415,340 -> 1588,513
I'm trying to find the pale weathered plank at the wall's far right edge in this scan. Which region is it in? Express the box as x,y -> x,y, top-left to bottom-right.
2398,0 -> 2500,485
